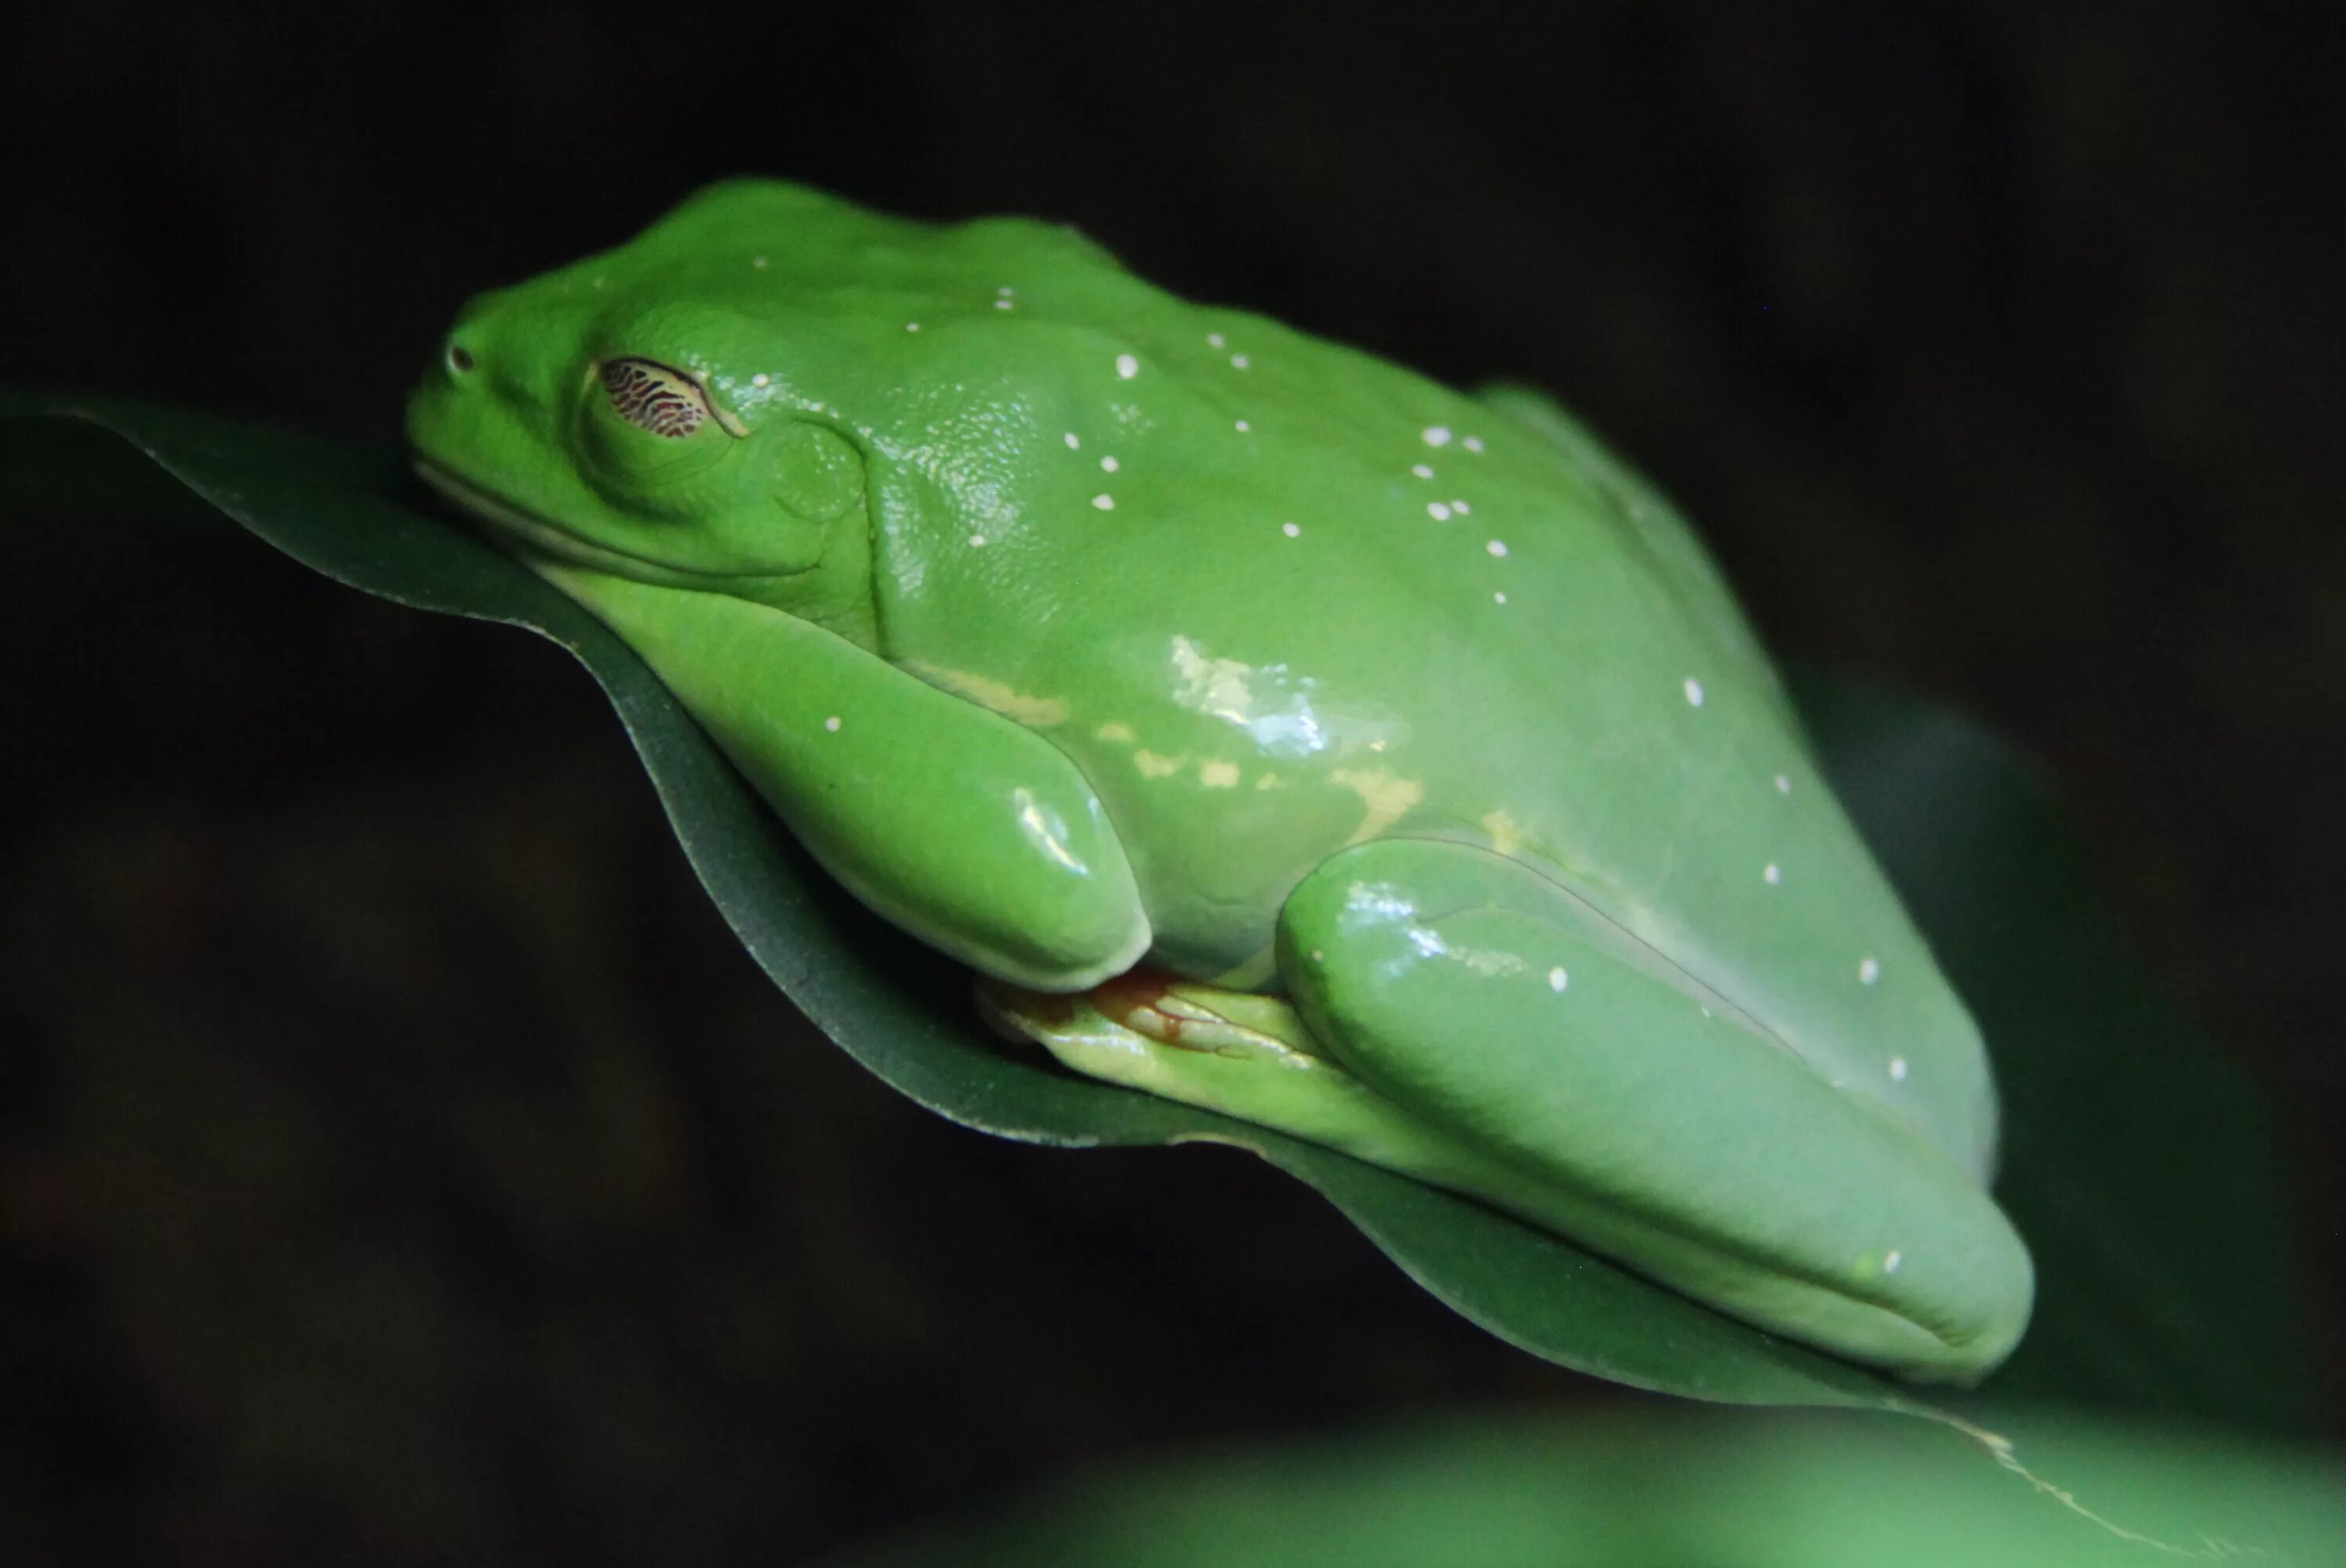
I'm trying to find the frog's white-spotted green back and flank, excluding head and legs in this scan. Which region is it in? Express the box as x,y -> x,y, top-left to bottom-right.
647,185 -> 1992,1162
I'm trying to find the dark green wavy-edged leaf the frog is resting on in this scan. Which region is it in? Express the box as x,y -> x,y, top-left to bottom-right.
0,392 -> 2308,1413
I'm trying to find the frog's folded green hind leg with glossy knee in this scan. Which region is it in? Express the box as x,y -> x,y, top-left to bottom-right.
1279,841 -> 2032,1383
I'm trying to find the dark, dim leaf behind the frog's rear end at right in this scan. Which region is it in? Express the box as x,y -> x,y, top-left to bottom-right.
1797,678 -> 2320,1432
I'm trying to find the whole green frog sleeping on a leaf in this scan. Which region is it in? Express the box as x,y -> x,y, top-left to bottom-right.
408,183 -> 2032,1380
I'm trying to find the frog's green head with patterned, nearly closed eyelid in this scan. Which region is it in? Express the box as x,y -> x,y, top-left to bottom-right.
408,211 -> 870,638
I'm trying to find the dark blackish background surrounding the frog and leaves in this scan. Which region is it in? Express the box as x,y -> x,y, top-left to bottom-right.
0,0 -> 2346,1563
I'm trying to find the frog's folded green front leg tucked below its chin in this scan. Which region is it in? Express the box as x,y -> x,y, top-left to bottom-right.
535,563 -> 1150,991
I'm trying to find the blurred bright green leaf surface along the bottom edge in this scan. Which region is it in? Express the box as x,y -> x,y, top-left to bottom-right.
828,1404 -> 2346,1568
